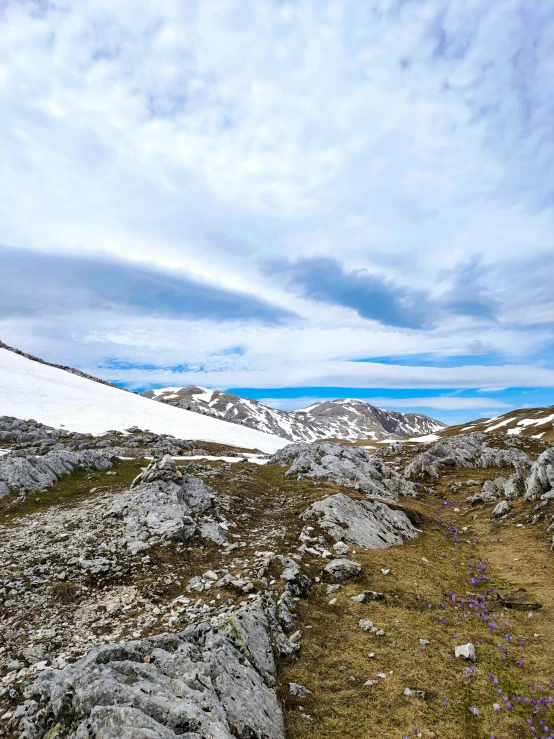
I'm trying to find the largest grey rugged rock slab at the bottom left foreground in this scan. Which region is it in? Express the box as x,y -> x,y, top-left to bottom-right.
23,601 -> 284,739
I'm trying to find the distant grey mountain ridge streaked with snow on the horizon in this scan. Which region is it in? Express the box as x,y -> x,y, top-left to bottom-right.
142,385 -> 446,441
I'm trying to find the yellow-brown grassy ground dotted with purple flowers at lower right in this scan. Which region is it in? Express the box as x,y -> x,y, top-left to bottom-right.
281,470 -> 554,739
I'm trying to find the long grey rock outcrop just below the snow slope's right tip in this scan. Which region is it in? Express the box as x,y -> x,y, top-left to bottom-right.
269,442 -> 417,501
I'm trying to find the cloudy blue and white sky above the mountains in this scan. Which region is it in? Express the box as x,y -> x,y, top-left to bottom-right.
0,0 -> 554,423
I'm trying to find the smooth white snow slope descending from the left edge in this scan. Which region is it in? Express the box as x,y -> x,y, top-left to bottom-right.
0,348 -> 288,452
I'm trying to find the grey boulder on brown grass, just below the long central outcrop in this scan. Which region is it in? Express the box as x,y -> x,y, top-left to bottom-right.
300,493 -> 418,549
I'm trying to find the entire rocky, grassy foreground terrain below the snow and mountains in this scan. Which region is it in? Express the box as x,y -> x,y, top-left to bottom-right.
0,418 -> 554,739
